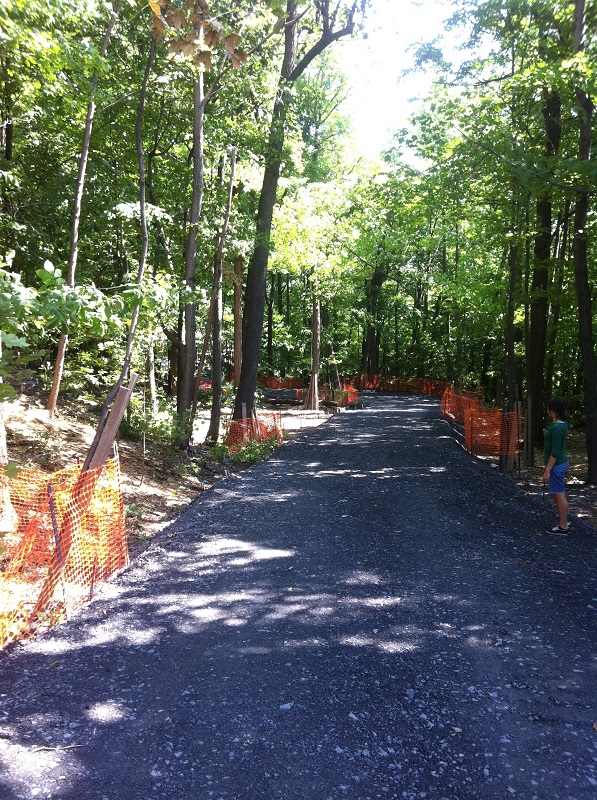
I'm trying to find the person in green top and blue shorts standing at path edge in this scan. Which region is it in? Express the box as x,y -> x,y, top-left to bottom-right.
543,397 -> 568,536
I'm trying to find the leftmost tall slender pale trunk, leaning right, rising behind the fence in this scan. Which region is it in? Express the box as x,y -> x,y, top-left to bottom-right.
46,0 -> 122,417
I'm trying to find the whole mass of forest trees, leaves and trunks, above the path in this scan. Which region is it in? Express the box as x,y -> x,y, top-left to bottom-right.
0,0 -> 597,476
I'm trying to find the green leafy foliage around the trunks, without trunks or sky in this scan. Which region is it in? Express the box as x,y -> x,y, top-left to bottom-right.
0,0 -> 597,450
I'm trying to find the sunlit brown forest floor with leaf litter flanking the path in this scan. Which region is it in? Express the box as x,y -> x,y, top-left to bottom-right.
5,396 -> 597,552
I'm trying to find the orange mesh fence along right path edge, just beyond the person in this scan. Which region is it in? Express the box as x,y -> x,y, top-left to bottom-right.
441,386 -> 522,456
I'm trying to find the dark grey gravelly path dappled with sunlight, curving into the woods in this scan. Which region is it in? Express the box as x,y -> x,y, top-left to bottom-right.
0,395 -> 597,800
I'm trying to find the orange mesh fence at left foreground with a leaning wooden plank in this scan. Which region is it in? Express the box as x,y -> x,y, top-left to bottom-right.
0,459 -> 128,649
